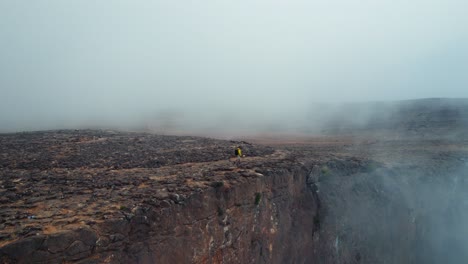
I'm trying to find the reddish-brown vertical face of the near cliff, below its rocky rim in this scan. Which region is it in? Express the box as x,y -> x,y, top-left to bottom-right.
0,161 -> 318,263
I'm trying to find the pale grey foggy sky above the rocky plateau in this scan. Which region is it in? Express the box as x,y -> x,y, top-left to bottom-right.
0,0 -> 468,129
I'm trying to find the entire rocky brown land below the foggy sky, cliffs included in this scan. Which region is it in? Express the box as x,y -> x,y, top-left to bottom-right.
0,98 -> 468,264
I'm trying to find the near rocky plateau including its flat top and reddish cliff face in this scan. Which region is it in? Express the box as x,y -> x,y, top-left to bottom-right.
0,130 -> 336,263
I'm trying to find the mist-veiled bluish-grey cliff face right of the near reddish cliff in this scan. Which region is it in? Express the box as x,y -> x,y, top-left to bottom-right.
306,141 -> 468,264
